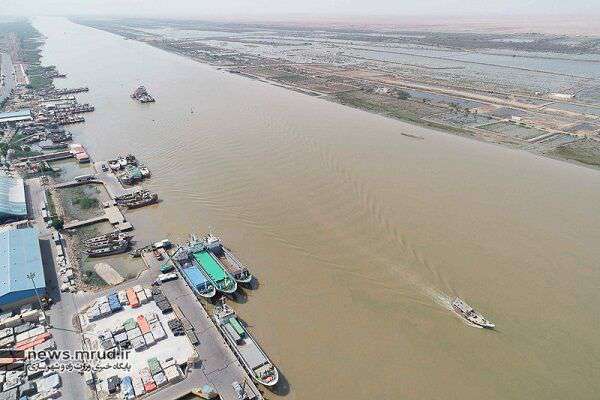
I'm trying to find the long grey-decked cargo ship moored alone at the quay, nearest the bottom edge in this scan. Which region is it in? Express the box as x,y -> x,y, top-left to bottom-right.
213,303 -> 279,386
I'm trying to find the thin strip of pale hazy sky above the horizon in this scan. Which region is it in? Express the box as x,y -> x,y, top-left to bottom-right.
0,0 -> 600,17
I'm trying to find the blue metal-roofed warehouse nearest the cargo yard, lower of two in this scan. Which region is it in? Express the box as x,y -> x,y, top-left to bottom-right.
0,228 -> 46,310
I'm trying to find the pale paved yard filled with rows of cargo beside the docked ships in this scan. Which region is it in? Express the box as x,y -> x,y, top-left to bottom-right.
80,285 -> 197,399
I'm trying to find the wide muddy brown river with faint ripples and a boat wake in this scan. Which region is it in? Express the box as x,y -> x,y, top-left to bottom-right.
34,19 -> 600,400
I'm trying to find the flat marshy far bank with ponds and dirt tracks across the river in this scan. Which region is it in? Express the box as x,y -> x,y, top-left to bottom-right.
76,19 -> 600,169
